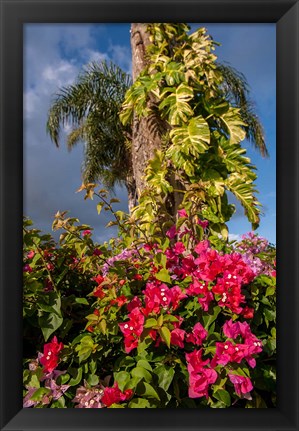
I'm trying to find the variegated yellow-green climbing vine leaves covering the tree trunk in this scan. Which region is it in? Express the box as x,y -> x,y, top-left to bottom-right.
120,24 -> 260,237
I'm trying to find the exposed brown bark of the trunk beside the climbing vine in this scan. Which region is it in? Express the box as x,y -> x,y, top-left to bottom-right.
131,23 -> 161,196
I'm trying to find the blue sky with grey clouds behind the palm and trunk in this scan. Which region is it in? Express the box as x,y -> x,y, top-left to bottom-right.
23,23 -> 276,243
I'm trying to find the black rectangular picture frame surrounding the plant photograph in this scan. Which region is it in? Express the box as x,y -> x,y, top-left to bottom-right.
0,0 -> 299,431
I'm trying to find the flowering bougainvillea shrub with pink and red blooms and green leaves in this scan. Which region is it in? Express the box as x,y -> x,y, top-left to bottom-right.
23,195 -> 276,408
